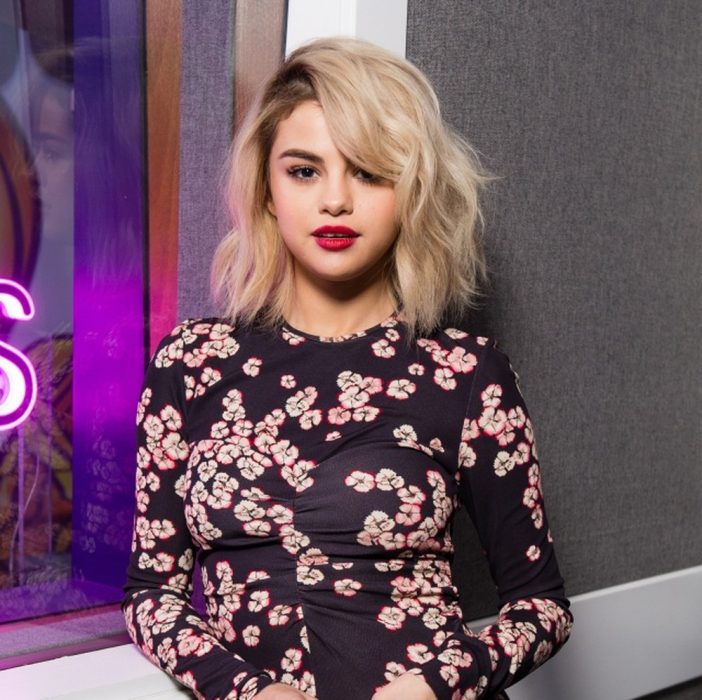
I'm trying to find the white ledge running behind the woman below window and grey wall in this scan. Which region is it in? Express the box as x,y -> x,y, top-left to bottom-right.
0,566 -> 702,700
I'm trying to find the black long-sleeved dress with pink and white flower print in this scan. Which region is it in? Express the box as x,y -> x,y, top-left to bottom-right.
124,317 -> 572,700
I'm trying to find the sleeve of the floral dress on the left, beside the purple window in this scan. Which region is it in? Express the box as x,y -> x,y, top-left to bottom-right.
123,324 -> 273,700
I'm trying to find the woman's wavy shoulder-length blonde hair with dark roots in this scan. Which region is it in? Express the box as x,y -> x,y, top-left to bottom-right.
212,38 -> 488,334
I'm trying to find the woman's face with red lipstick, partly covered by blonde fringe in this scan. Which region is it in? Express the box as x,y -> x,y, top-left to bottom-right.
268,102 -> 397,293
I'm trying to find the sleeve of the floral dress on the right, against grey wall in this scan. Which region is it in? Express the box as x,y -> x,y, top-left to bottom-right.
422,344 -> 572,698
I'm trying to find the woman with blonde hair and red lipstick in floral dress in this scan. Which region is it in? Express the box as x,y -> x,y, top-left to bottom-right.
124,39 -> 571,700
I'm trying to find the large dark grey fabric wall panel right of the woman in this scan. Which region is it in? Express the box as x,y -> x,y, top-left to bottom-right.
407,0 -> 702,604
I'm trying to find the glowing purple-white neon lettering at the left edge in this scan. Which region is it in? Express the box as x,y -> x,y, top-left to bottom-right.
0,279 -> 37,430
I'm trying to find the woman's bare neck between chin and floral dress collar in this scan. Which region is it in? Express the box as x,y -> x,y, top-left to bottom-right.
285,266 -> 395,337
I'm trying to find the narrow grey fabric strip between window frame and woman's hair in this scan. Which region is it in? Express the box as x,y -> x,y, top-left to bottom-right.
178,0 -> 234,318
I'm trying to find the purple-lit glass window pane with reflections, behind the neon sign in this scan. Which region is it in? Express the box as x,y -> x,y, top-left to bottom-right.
0,0 -> 146,658
